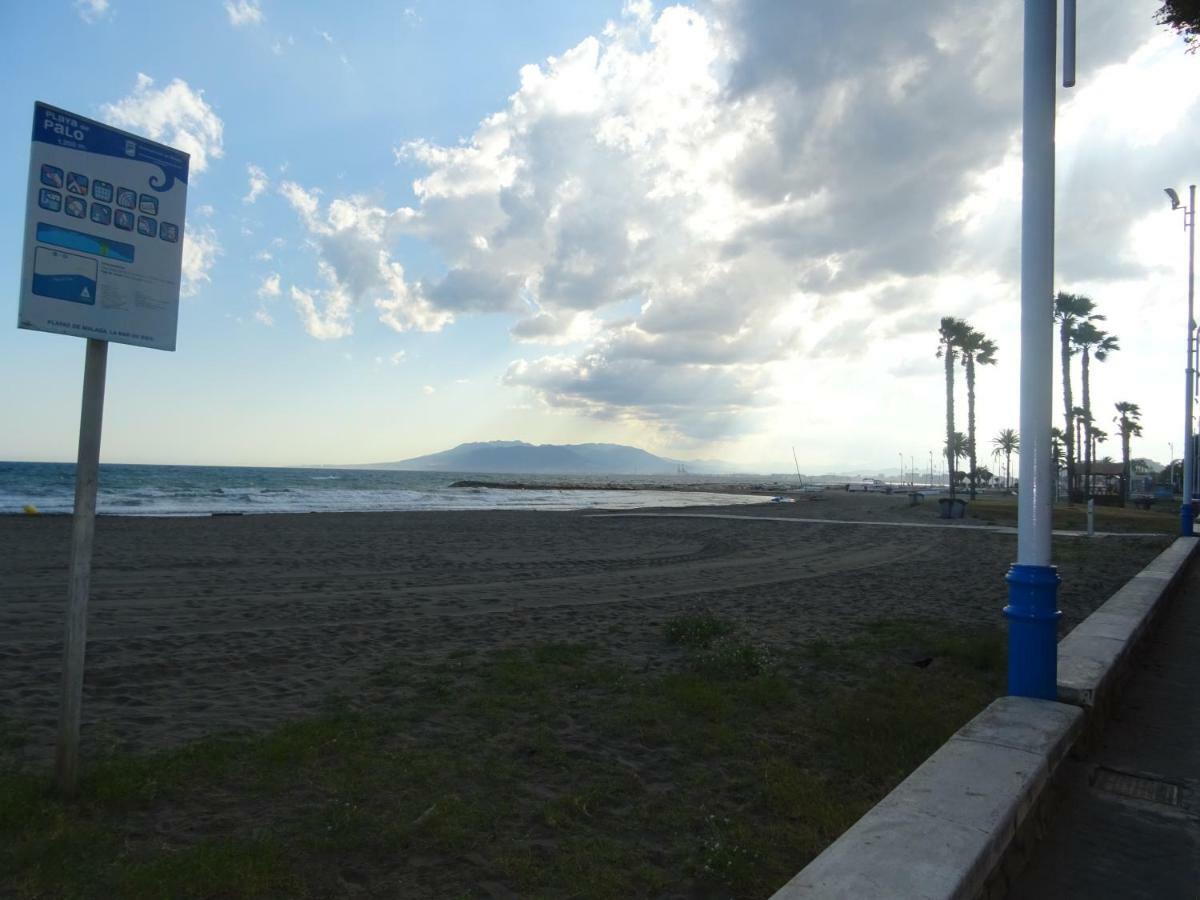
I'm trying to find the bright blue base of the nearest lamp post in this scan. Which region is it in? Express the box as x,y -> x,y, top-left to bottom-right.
1004,563 -> 1062,700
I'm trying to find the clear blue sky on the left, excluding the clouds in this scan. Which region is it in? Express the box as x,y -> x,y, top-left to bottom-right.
0,1 -> 619,463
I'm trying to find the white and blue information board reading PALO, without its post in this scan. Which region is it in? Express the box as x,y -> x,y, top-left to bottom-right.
17,103 -> 188,350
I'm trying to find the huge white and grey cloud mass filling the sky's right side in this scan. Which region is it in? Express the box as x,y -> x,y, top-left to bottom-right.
270,0 -> 1200,451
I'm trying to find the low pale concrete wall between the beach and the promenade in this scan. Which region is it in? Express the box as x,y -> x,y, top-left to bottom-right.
773,538 -> 1200,900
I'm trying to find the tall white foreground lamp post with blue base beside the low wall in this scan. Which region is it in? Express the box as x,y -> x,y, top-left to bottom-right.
1004,0 -> 1075,700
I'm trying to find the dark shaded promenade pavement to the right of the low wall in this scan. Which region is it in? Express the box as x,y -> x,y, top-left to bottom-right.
1009,560 -> 1200,900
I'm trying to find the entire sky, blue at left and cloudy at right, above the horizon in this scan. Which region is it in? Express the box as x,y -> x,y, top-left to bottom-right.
0,0 -> 1200,472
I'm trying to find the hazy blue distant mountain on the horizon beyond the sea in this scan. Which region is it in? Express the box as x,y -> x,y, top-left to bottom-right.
360,440 -> 734,475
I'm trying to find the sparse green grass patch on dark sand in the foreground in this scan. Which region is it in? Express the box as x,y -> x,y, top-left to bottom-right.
0,617 -> 1003,898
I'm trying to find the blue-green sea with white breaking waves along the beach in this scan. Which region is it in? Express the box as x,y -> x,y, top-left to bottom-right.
0,462 -> 772,516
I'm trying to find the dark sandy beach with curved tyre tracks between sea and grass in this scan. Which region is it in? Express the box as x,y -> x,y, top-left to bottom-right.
0,492 -> 1168,761
